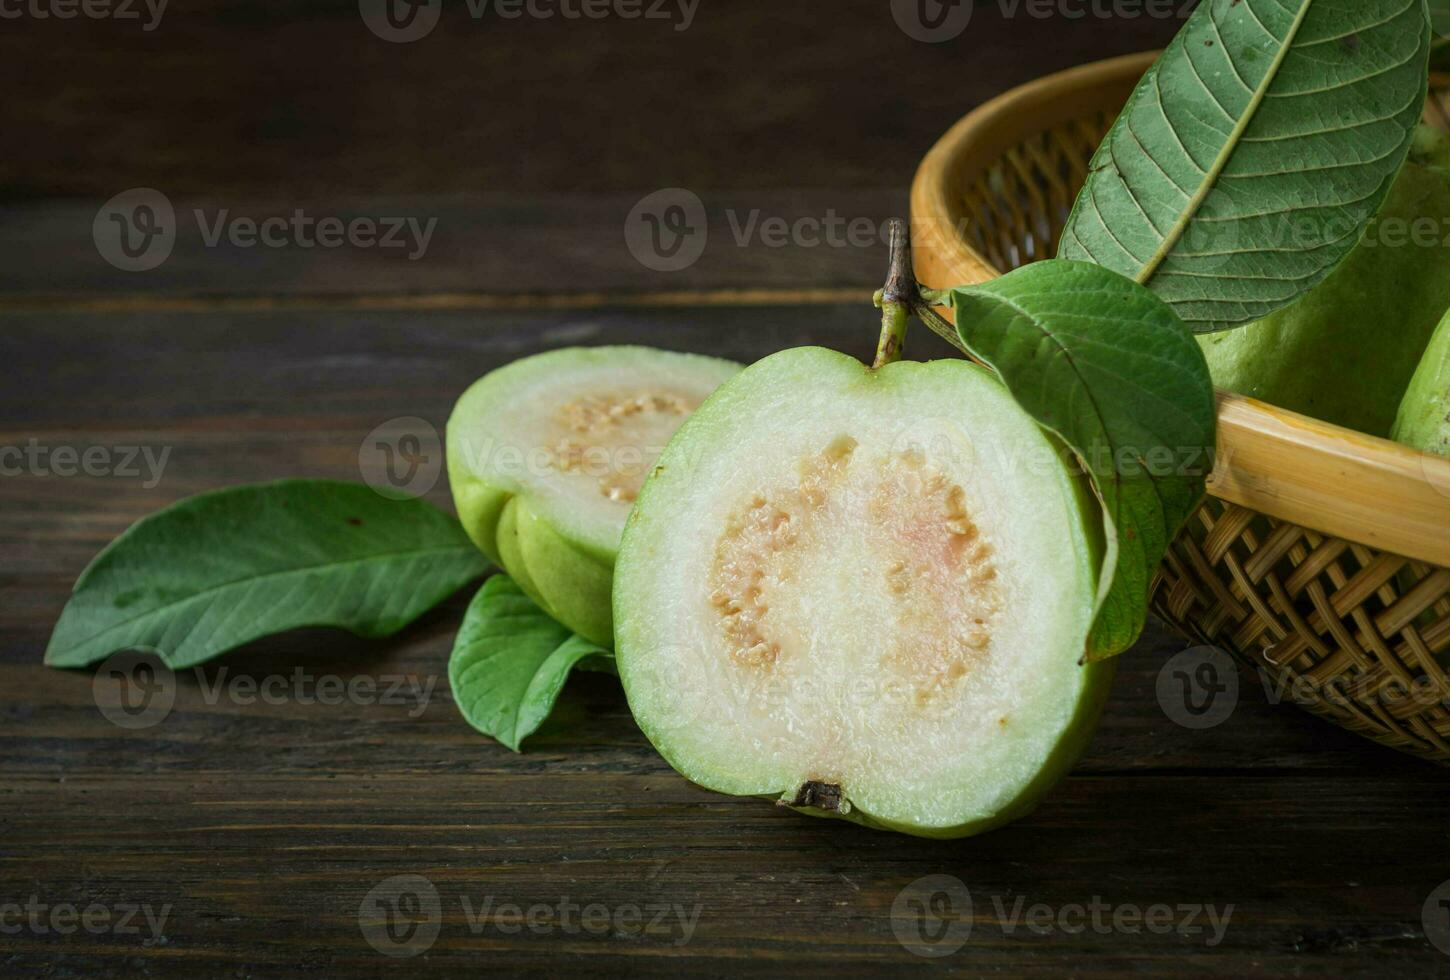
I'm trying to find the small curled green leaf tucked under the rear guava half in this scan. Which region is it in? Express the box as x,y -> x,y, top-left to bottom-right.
448,576 -> 615,752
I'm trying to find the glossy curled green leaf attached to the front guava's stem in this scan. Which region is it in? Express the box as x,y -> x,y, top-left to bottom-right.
945,259 -> 1217,660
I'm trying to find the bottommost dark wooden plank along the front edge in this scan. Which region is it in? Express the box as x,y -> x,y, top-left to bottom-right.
4,771 -> 1444,977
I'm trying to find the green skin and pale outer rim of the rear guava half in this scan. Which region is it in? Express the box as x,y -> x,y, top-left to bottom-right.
447,346 -> 740,648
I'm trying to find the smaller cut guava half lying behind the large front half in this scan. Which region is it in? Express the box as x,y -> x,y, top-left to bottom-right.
448,346 -> 740,647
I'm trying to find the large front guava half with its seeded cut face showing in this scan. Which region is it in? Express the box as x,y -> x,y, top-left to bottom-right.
615,348 -> 1112,836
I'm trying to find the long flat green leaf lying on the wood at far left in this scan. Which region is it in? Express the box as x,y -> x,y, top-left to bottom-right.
45,480 -> 489,670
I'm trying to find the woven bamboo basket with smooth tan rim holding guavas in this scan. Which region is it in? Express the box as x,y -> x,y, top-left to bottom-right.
911,52 -> 1450,764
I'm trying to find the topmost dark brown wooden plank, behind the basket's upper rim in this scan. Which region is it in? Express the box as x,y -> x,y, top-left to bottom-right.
0,7 -> 1182,204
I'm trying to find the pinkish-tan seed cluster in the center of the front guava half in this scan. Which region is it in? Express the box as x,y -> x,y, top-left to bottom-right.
709,435 -> 1003,707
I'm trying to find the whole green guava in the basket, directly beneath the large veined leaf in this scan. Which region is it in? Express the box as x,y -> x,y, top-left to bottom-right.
1198,130 -> 1450,436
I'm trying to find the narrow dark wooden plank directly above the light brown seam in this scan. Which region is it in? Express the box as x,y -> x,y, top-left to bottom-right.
0,191 -> 906,297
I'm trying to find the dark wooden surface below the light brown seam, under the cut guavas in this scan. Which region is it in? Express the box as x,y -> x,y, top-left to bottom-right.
8,303 -> 1450,977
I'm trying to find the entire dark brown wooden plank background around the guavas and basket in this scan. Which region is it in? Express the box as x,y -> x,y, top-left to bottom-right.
0,0 -> 1450,977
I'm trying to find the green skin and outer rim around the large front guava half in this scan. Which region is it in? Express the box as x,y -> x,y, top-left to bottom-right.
613,348 -> 1117,839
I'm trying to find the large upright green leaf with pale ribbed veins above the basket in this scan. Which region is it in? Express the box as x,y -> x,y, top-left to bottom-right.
1059,0 -> 1430,332
